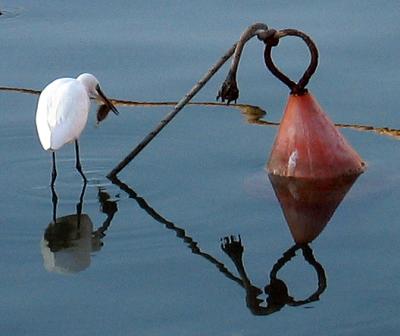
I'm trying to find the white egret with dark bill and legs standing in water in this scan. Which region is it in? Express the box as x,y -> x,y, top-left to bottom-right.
36,73 -> 118,186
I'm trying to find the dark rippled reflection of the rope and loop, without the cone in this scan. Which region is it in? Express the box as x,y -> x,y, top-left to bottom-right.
112,178 -> 327,315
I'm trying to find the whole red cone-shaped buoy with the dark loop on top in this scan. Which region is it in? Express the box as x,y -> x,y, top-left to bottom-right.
263,29 -> 365,179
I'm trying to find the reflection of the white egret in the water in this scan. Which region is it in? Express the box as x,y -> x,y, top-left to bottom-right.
41,184 -> 118,274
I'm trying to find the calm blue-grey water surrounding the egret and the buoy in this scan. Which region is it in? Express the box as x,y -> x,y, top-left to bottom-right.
0,0 -> 400,335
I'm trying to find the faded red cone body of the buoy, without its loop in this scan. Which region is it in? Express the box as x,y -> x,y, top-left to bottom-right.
267,92 -> 365,178
